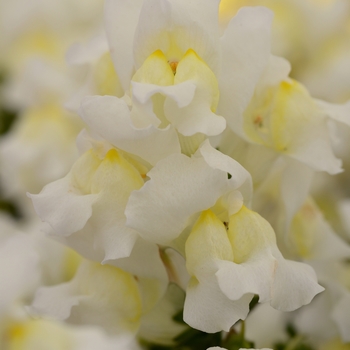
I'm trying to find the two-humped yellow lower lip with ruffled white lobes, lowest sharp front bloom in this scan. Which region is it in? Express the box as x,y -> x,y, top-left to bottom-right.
185,206 -> 323,331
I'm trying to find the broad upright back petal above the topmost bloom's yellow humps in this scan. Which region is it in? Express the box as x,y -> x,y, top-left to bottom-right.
134,0 -> 220,71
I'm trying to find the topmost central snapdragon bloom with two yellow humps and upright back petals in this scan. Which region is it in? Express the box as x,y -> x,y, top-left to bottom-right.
106,1 -> 225,136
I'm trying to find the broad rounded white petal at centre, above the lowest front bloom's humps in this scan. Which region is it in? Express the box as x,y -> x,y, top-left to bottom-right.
125,155 -> 228,244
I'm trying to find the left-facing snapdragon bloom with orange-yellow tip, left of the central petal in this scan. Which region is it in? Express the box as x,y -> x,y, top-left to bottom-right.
30,149 -> 143,261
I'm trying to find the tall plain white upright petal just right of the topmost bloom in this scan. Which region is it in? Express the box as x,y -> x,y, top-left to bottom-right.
218,7 -> 272,137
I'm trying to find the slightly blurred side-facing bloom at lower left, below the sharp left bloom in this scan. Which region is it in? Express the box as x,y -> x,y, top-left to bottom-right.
30,261 -> 142,335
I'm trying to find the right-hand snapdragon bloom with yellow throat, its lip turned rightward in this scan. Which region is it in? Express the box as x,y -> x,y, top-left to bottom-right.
223,56 -> 349,174
